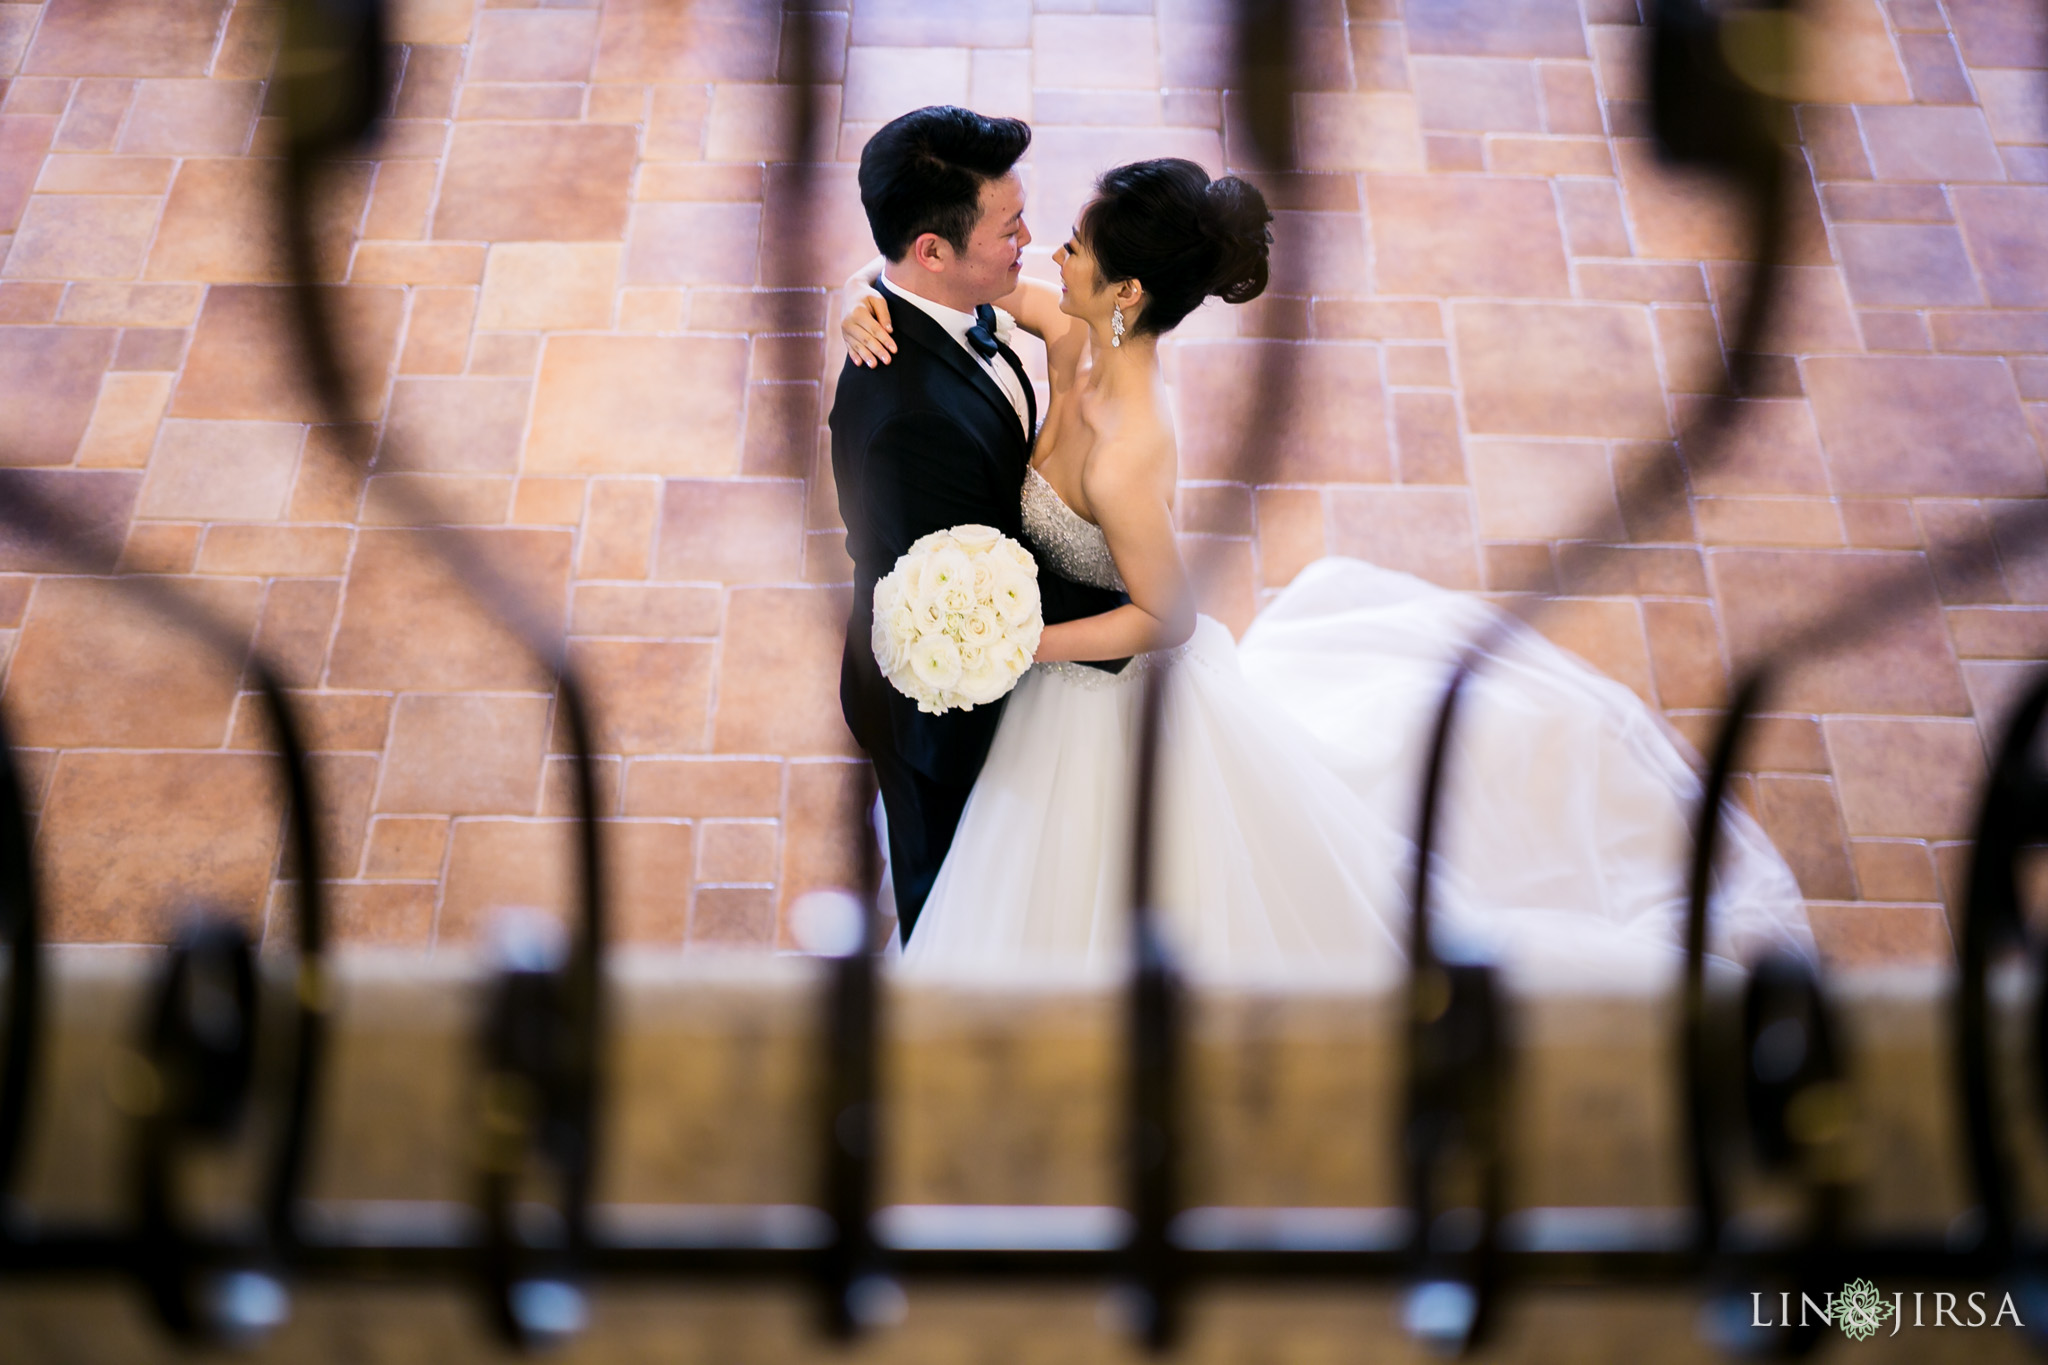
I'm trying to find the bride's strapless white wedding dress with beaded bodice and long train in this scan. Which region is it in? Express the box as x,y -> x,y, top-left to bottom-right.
901,471 -> 1812,980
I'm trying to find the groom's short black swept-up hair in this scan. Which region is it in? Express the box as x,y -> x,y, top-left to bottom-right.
860,104 -> 1030,260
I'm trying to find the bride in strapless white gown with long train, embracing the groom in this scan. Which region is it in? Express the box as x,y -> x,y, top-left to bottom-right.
842,160 -> 1812,980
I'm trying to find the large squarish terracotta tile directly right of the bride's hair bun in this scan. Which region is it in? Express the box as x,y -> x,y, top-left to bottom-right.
1366,176 -> 1571,297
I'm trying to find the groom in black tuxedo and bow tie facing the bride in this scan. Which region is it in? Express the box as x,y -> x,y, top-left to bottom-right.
829,106 -> 1122,941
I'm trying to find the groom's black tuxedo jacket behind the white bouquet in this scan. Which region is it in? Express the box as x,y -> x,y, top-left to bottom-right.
829,284 -> 1128,786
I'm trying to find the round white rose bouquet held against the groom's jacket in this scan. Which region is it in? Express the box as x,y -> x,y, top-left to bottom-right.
872,526 -> 1044,716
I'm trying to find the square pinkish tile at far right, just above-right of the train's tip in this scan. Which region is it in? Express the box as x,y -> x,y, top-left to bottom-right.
1821,716 -> 1985,839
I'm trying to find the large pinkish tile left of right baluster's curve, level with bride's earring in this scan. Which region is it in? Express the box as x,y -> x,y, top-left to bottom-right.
1452,303 -> 1671,436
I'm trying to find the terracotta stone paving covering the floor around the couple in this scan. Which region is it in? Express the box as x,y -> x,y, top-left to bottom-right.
0,0 -> 2048,962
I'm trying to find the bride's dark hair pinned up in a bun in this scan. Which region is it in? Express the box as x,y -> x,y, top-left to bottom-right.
1079,156 -> 1274,336
